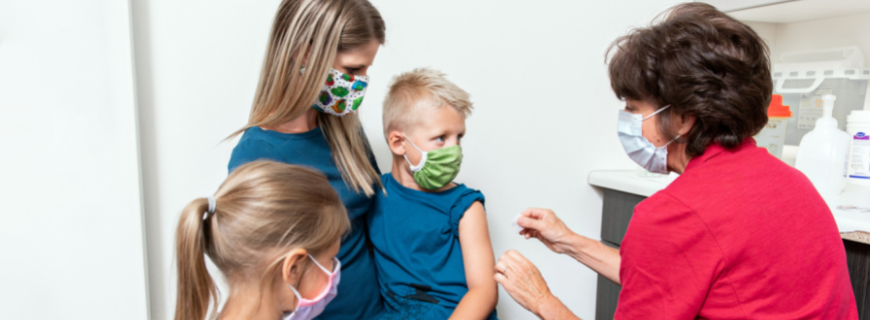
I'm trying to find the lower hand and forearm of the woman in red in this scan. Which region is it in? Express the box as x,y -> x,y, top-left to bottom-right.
495,250 -> 578,319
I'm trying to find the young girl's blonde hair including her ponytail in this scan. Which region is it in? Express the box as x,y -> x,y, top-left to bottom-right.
175,161 -> 350,320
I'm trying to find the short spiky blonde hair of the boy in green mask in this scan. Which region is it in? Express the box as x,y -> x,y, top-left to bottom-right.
384,68 -> 474,138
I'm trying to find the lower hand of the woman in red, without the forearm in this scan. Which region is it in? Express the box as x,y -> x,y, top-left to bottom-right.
495,250 -> 552,317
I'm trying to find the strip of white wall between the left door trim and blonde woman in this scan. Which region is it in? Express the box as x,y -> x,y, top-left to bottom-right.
133,0 -> 270,319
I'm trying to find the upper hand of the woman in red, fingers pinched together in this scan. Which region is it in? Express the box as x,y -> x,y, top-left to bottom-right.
517,208 -> 575,253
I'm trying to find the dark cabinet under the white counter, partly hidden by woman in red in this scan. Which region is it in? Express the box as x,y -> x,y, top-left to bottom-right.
595,189 -> 870,320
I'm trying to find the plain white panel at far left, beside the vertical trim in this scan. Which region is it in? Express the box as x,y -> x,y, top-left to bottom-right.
0,0 -> 149,320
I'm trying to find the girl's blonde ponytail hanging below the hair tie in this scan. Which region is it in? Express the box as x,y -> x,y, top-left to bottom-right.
175,198 -> 217,320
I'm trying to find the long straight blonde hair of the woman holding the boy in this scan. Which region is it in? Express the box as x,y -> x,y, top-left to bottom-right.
230,0 -> 386,196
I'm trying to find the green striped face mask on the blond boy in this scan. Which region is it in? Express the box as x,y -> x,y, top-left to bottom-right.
403,135 -> 462,190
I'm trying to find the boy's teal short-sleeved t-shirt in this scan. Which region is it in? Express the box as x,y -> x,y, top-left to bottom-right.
368,173 -> 497,320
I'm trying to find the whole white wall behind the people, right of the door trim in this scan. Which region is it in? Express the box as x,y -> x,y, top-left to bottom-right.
133,0 -> 677,320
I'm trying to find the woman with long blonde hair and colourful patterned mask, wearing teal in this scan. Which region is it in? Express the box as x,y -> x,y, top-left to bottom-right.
229,0 -> 386,320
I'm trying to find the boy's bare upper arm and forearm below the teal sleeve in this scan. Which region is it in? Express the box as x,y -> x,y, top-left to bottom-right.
450,201 -> 498,319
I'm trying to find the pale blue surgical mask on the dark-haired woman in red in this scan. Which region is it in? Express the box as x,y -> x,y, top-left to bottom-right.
616,105 -> 680,174
